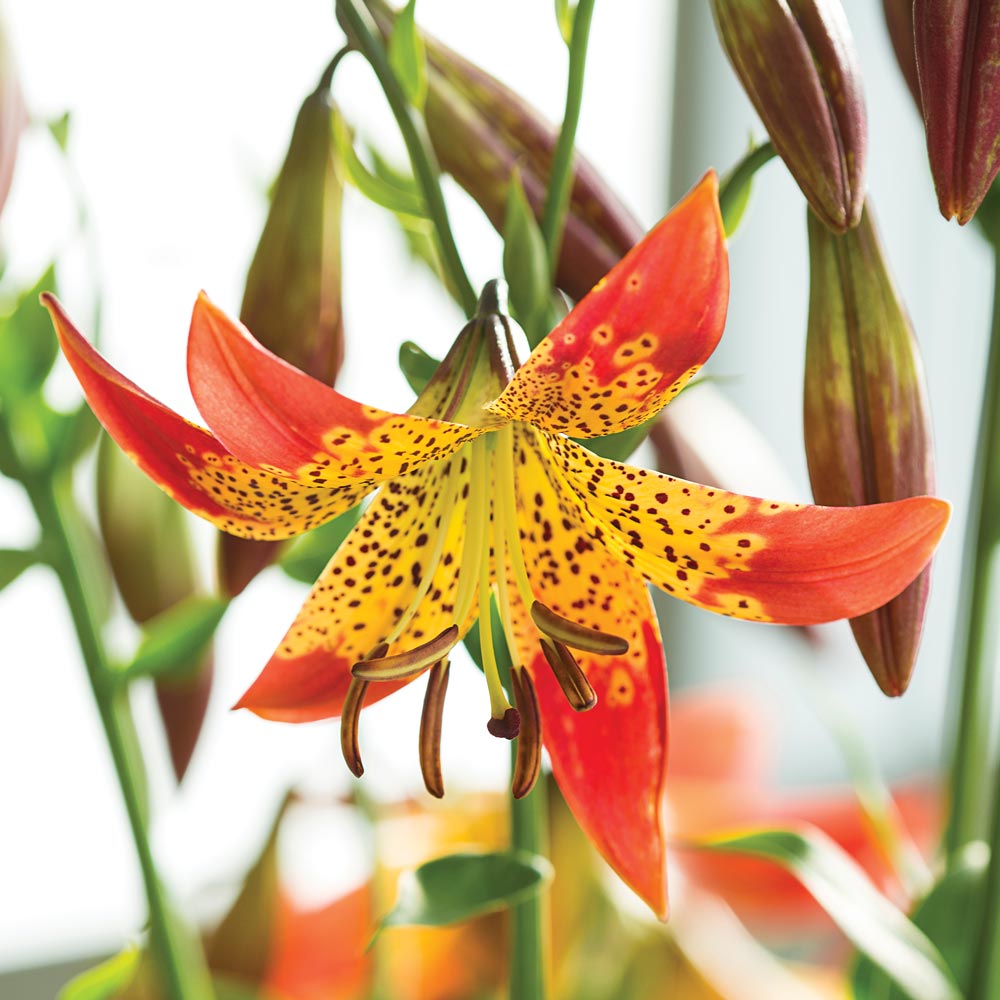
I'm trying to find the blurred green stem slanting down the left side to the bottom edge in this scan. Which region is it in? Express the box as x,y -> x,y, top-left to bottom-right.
0,418 -> 213,1000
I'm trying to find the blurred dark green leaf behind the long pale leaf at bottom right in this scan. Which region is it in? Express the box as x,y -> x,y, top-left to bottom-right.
851,842 -> 990,1000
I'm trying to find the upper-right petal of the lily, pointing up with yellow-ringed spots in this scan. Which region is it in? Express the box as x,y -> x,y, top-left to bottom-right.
489,173 -> 729,437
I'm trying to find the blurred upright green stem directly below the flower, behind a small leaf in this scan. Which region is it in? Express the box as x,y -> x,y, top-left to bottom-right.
508,743 -> 549,1000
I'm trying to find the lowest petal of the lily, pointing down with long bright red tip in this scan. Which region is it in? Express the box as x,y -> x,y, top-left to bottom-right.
511,428 -> 668,916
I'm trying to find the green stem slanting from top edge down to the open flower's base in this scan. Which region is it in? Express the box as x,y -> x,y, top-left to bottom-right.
337,0 -> 478,317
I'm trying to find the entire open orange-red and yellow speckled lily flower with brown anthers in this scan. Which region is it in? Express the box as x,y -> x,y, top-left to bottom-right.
43,174 -> 948,914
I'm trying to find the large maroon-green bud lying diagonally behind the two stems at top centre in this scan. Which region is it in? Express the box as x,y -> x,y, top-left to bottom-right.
366,0 -> 645,299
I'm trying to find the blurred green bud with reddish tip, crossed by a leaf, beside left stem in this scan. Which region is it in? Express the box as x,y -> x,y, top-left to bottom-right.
97,435 -> 213,781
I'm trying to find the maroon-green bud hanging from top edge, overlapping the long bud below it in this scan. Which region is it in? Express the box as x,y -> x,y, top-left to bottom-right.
712,0 -> 868,232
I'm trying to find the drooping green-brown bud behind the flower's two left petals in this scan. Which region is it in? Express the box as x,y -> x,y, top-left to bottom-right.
219,84 -> 344,596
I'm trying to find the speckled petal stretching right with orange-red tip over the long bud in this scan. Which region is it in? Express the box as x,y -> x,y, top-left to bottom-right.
549,436 -> 950,625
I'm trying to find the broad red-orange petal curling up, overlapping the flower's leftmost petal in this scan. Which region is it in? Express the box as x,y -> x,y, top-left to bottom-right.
188,293 -> 482,487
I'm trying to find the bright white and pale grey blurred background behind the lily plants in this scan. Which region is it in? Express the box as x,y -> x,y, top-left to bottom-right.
0,0 -> 991,983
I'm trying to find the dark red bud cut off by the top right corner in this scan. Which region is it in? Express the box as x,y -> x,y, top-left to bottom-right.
913,0 -> 1000,225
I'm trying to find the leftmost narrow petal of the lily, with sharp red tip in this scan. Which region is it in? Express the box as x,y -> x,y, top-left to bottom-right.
42,293 -> 367,540
